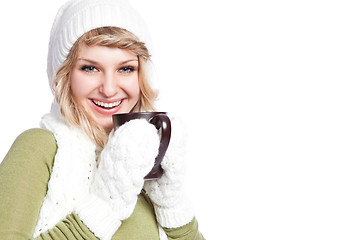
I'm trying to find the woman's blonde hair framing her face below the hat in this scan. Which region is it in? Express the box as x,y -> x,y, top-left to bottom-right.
52,27 -> 158,148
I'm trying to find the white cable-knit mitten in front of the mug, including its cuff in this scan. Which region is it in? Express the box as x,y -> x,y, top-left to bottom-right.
76,119 -> 159,239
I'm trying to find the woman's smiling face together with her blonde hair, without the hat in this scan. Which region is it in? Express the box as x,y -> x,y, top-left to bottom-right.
53,27 -> 157,146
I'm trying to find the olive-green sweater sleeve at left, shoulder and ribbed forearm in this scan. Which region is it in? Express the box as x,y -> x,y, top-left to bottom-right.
0,129 -> 96,240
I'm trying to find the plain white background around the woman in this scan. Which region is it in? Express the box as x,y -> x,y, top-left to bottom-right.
0,0 -> 360,240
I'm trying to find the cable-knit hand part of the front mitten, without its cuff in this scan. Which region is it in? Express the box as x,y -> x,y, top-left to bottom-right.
94,119 -> 159,220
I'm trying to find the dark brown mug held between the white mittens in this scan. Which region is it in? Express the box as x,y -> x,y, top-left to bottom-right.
112,112 -> 171,180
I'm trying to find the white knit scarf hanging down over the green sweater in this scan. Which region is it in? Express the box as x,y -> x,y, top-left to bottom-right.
33,104 -> 167,240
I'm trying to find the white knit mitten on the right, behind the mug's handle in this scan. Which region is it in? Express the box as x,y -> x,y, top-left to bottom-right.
144,118 -> 195,228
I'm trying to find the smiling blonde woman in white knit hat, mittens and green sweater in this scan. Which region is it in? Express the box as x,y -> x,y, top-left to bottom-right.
0,0 -> 203,239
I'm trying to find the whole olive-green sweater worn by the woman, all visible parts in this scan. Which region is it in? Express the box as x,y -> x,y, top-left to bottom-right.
0,129 -> 204,240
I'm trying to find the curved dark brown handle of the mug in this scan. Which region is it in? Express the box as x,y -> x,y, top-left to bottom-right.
144,114 -> 171,180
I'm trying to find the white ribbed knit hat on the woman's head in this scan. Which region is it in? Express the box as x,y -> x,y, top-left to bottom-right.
47,0 -> 151,89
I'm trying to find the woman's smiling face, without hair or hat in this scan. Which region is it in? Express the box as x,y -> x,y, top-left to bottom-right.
70,43 -> 140,130
